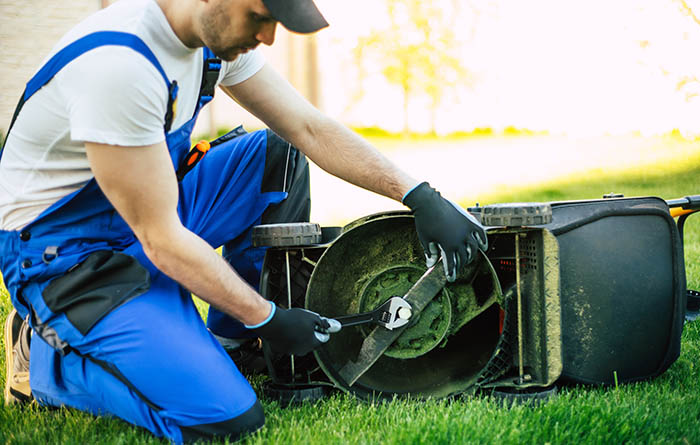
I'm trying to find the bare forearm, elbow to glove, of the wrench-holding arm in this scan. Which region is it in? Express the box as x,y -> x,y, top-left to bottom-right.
143,227 -> 271,325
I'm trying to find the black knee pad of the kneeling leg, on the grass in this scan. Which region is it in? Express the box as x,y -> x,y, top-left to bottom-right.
180,400 -> 265,443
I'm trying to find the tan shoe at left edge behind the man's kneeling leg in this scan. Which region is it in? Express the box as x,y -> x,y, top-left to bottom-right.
5,309 -> 33,405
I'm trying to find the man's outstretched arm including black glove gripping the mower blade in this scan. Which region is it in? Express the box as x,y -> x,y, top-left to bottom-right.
223,66 -> 488,281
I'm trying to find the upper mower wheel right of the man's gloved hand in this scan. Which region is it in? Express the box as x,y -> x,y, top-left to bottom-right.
481,202 -> 552,227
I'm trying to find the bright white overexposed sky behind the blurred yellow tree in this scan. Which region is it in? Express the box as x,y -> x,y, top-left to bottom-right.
317,0 -> 700,137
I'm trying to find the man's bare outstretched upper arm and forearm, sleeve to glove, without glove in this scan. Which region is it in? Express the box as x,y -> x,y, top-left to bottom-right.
222,62 -> 418,201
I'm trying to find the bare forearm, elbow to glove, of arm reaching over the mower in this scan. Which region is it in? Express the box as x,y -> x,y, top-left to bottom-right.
293,116 -> 418,201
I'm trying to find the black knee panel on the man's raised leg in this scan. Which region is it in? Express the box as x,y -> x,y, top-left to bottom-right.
261,130 -> 311,224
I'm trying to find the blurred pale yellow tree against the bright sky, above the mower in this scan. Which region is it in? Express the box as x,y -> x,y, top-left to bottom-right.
355,0 -> 468,132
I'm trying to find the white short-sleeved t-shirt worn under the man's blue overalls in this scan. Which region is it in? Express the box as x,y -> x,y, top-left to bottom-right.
0,0 -> 265,230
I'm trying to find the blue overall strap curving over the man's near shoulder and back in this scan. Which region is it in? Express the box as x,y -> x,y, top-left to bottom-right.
0,31 -> 178,156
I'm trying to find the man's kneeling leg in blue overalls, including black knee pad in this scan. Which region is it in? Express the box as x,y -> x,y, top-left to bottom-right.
30,258 -> 264,443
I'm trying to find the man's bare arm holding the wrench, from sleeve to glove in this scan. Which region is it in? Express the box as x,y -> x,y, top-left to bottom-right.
85,143 -> 271,325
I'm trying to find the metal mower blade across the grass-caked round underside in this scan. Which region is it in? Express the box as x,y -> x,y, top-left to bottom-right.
338,260 -> 447,386
